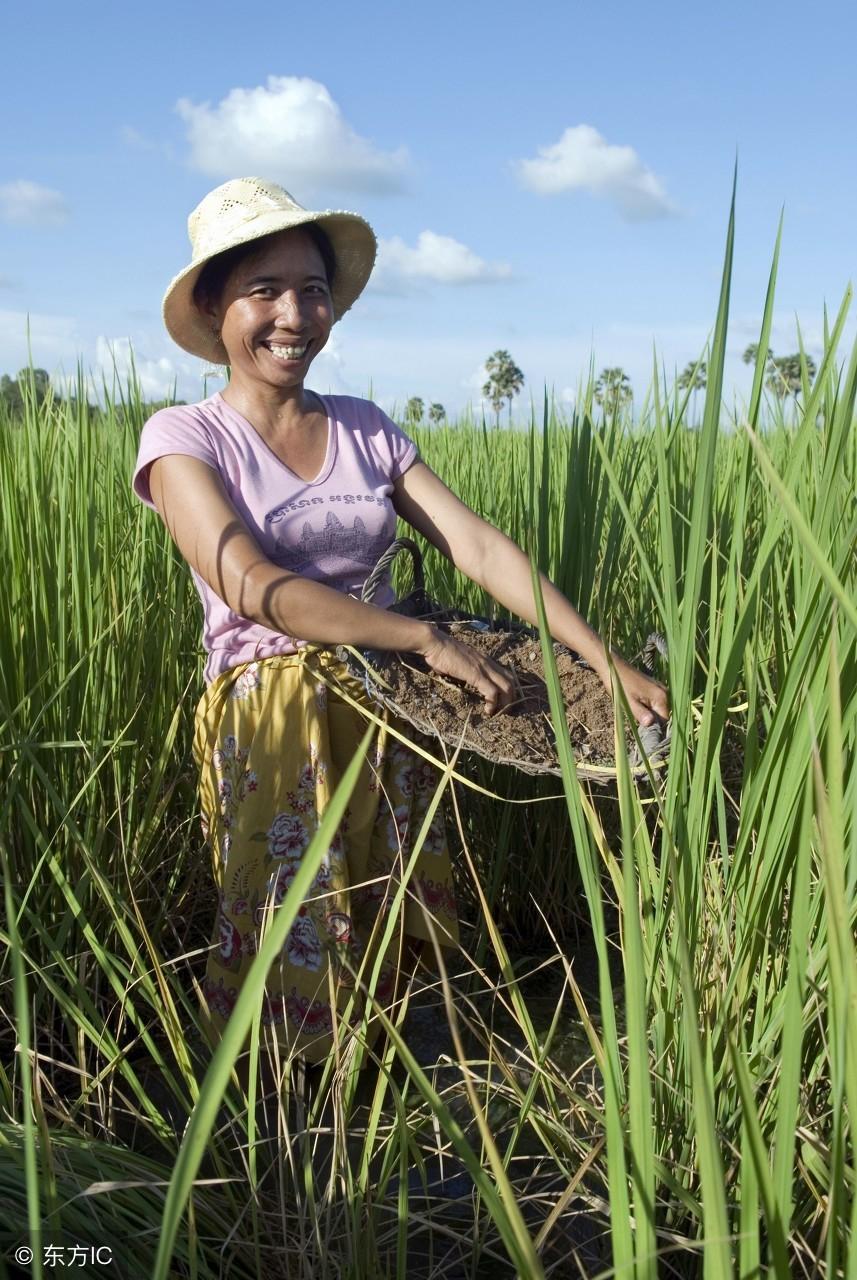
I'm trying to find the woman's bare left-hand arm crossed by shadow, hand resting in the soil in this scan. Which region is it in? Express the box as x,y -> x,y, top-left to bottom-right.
148,453 -> 515,713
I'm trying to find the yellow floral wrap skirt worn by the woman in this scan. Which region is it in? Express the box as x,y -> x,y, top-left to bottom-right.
193,648 -> 458,1062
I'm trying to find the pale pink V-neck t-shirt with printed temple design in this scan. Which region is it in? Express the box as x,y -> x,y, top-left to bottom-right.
133,392 -> 417,684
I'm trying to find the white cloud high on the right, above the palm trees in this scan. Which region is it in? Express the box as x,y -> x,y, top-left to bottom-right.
515,124 -> 675,221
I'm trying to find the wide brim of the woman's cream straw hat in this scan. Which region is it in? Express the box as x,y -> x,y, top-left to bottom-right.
164,209 -> 377,365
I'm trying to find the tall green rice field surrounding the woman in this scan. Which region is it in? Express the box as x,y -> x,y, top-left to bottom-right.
0,204 -> 857,1280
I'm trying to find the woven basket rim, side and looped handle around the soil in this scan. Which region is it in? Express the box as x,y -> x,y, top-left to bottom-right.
336,538 -> 669,786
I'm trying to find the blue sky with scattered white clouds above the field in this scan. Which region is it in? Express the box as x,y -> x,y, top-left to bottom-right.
0,0 -> 857,412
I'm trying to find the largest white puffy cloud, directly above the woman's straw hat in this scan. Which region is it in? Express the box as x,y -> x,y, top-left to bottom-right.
175,76 -> 408,197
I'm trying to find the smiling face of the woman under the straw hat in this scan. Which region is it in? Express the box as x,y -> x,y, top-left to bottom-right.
207,227 -> 334,388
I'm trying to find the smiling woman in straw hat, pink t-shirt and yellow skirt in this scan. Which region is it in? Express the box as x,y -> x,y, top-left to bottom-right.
134,178 -> 668,1061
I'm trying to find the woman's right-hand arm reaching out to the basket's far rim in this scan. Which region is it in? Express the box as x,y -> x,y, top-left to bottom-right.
393,462 -> 669,724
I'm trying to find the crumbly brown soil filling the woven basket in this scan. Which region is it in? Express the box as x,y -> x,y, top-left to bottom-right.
373,625 -> 631,765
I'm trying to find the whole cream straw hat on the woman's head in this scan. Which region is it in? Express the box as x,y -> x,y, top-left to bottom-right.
164,178 -> 377,365
